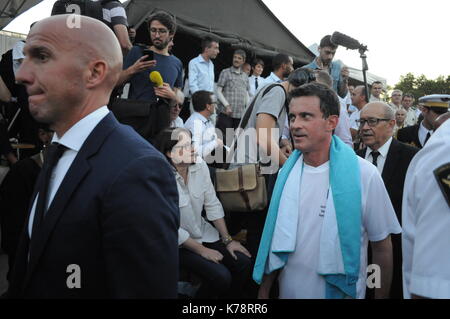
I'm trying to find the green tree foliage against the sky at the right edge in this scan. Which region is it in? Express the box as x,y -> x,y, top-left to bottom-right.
394,73 -> 450,99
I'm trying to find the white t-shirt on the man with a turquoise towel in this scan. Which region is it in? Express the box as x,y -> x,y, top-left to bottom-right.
279,158 -> 401,299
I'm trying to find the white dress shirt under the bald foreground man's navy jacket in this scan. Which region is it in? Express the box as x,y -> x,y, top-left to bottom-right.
28,105 -> 109,238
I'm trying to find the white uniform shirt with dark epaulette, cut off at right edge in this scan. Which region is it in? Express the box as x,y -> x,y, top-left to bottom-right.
402,120 -> 450,299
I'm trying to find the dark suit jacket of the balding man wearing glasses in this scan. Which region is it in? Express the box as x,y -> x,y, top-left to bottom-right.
356,139 -> 419,223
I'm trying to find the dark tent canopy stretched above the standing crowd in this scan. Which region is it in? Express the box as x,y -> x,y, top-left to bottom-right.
124,0 -> 315,75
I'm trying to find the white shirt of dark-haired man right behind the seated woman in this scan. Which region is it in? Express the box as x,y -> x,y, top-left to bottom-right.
184,112 -> 217,158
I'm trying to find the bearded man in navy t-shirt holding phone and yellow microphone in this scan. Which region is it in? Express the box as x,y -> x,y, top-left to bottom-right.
118,12 -> 183,103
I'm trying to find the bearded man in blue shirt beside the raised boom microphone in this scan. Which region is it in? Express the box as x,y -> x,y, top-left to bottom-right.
303,35 -> 349,98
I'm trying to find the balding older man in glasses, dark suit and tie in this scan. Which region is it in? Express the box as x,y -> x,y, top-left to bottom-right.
357,102 -> 418,298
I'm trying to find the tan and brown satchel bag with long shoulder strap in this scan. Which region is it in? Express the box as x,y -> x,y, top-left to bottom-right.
215,84 -> 280,212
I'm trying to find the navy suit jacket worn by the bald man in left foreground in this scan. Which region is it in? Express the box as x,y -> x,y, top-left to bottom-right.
9,113 -> 179,298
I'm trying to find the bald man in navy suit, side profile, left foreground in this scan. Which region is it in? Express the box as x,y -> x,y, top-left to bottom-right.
9,15 -> 179,298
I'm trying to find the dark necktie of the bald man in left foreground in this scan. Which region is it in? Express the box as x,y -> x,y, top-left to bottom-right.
33,143 -> 66,234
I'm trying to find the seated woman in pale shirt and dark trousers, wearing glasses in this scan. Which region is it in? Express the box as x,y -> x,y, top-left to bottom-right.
155,128 -> 251,298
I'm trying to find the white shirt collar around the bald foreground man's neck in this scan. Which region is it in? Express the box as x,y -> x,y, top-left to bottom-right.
52,105 -> 109,152
